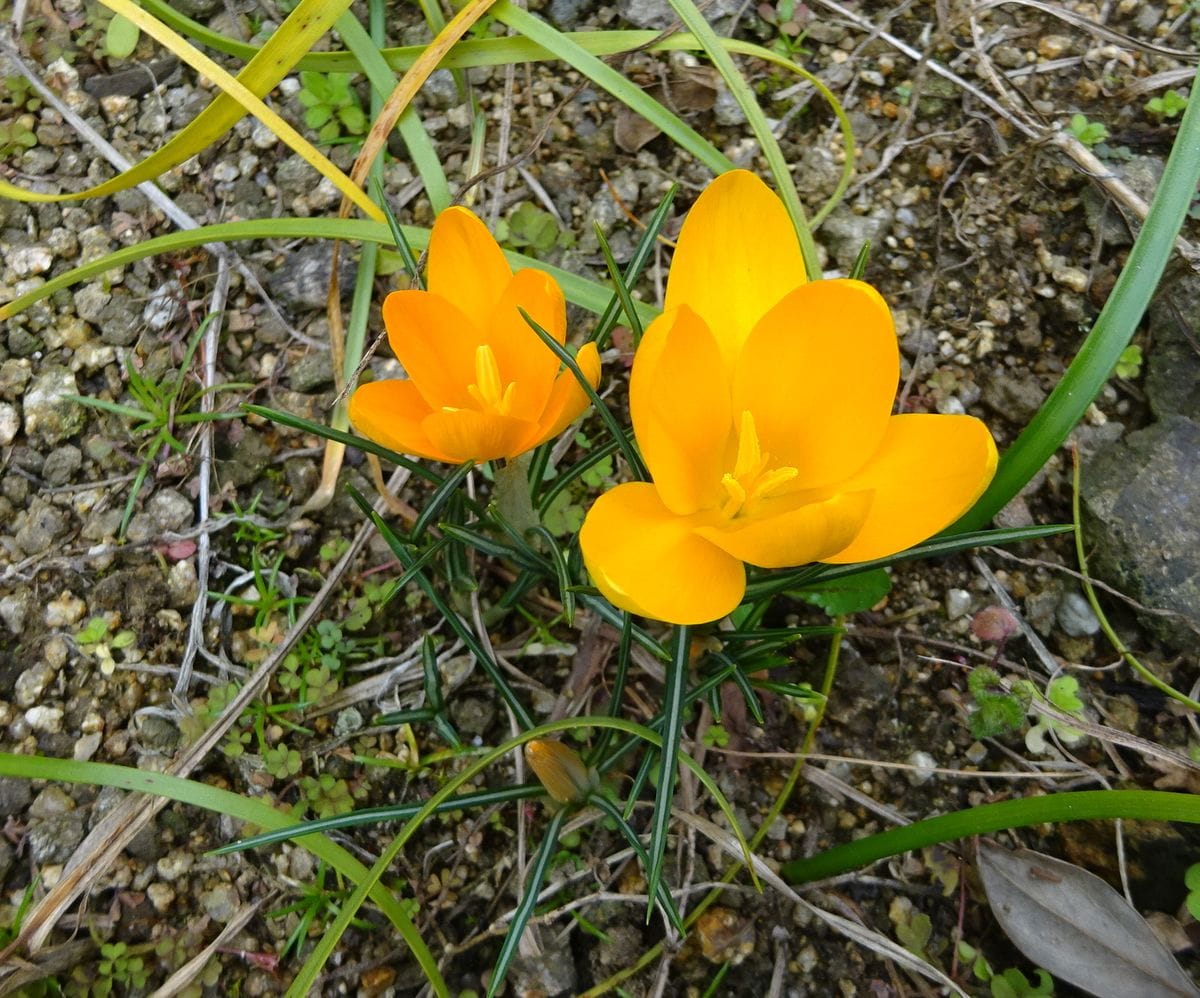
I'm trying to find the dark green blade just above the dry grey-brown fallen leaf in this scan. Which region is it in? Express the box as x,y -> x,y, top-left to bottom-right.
779,790 -> 1200,884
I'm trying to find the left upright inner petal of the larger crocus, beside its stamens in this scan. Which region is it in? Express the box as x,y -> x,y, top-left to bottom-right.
629,305 -> 733,516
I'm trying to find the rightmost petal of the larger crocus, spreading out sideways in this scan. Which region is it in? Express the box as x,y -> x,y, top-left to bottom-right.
821,415 -> 996,564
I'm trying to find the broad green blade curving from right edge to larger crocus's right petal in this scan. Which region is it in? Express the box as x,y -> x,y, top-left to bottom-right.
947,89 -> 1200,534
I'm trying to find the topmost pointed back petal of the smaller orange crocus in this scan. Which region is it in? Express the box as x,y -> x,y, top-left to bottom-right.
426,206 -> 512,330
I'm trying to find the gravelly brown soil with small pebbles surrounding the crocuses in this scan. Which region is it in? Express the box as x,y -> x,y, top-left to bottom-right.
0,0 -> 1200,996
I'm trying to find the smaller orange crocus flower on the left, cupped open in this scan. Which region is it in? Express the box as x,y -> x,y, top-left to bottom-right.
349,208 -> 600,464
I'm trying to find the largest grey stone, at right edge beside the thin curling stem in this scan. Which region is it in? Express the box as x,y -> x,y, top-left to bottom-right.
1080,416 -> 1200,650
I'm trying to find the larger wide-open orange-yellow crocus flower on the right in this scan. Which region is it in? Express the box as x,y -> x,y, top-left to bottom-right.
580,170 -> 996,624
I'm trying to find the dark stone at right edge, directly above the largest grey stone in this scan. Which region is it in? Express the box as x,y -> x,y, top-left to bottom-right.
1145,268 -> 1200,420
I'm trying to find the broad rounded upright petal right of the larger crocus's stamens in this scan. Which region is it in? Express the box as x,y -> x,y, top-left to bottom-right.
733,281 -> 900,488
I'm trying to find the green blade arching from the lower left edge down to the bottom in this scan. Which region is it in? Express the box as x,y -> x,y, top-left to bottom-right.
0,752 -> 450,996
